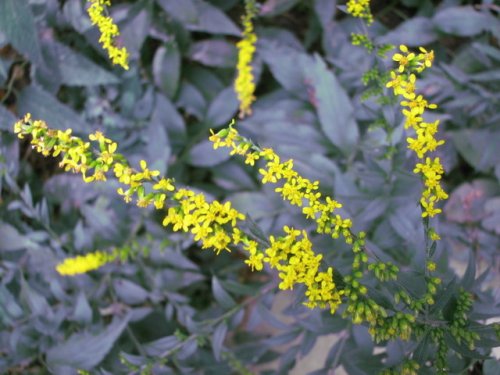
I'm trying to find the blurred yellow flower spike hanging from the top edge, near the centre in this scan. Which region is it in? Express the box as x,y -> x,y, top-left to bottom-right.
234,0 -> 257,118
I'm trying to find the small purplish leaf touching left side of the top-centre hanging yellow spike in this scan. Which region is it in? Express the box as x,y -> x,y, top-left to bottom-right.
189,39 -> 237,68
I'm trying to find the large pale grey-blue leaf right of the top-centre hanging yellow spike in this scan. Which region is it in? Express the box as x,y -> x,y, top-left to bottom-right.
303,55 -> 359,156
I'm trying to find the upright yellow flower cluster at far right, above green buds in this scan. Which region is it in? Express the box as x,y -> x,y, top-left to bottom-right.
386,45 -> 448,219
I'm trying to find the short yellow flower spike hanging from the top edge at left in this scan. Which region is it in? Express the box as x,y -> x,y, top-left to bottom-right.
87,0 -> 128,70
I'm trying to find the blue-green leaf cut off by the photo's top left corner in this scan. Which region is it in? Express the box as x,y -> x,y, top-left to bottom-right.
0,0 -> 41,63
